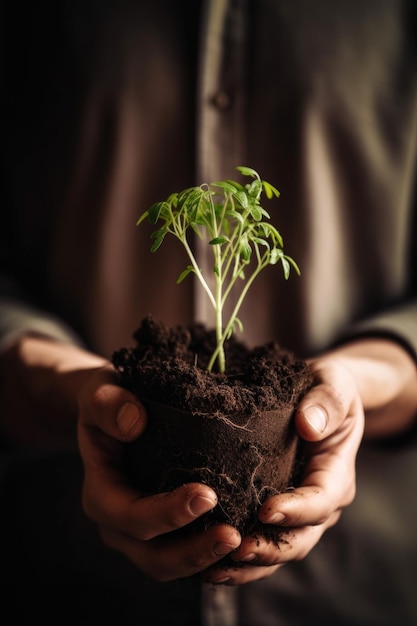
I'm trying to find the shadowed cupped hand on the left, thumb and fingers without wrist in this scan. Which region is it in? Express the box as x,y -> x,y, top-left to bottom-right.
78,366 -> 241,581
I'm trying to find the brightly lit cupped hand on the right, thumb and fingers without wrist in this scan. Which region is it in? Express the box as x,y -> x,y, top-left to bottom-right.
204,359 -> 364,585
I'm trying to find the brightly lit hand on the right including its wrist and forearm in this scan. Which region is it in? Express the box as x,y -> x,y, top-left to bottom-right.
200,339 -> 417,585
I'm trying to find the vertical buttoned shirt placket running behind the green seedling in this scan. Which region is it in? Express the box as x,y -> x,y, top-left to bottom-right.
194,0 -> 247,626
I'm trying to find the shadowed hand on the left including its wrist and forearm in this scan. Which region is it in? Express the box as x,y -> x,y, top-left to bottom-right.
0,336 -> 241,581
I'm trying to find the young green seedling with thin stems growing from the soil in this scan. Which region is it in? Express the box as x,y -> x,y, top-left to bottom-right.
137,166 -> 300,373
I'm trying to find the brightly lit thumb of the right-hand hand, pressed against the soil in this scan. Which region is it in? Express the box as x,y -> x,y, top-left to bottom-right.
295,363 -> 359,441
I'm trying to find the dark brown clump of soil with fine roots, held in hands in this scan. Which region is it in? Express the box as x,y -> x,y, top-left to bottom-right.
112,317 -> 313,539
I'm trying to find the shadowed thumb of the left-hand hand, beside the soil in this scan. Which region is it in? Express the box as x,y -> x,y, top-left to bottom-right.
79,366 -> 147,441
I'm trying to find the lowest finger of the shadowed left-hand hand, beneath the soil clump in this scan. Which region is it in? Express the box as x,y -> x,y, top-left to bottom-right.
100,525 -> 241,582
